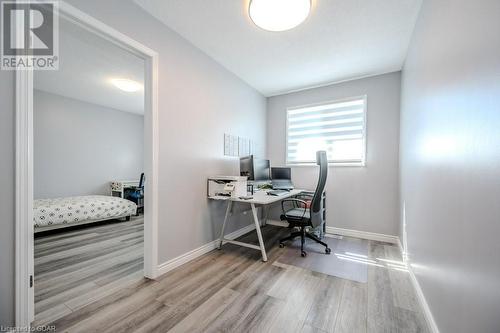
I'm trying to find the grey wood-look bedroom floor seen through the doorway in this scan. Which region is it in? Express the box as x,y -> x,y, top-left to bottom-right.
34,216 -> 144,326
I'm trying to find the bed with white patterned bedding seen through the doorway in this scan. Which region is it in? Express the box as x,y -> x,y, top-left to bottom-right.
33,195 -> 137,232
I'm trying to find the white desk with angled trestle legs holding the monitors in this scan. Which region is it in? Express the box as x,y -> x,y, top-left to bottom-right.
209,190 -> 304,261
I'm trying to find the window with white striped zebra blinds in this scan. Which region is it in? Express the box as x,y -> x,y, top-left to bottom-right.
286,96 -> 366,165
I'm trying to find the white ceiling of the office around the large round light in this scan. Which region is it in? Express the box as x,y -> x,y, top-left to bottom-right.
135,0 -> 422,96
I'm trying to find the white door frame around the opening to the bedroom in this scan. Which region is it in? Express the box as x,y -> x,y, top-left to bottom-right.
15,1 -> 159,327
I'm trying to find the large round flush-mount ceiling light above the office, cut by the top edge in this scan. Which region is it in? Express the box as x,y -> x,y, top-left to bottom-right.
248,0 -> 311,31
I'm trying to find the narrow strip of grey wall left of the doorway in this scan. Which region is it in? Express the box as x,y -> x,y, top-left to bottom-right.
0,70 -> 15,326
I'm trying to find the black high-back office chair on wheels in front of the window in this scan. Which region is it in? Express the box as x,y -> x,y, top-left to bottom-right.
279,151 -> 331,257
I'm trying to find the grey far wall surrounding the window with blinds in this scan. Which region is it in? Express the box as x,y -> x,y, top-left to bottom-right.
267,72 -> 400,235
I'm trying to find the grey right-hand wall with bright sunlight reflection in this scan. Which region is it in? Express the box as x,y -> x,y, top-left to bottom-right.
401,0 -> 500,333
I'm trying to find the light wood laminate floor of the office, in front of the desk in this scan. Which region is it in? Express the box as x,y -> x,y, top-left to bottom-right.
34,223 -> 428,333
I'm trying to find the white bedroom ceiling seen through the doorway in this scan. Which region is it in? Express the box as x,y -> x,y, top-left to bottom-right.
34,19 -> 144,114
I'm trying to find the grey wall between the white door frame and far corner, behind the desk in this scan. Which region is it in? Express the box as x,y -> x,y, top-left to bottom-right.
64,0 -> 266,263
